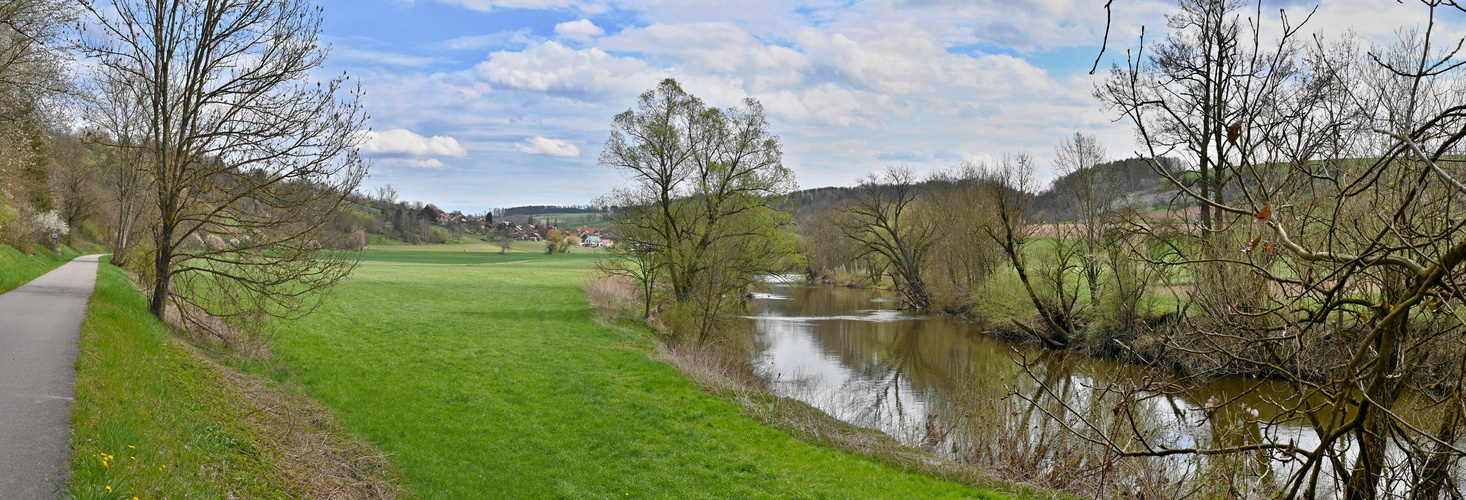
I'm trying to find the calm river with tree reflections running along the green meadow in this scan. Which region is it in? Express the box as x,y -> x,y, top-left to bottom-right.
746,279 -> 1462,497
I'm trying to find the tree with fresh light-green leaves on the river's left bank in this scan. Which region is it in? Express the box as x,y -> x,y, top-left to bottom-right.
600,79 -> 795,342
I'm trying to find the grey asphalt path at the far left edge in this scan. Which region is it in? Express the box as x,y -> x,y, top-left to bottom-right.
0,255 -> 100,499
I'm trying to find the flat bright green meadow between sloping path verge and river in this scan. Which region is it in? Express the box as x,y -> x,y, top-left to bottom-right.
276,246 -> 998,499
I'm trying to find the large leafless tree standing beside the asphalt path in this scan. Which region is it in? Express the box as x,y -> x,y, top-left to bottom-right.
81,0 -> 367,331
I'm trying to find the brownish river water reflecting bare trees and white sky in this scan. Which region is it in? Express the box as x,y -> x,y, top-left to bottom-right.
748,278 -> 1436,492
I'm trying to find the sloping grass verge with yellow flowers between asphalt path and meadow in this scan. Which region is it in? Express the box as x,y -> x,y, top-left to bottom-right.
66,259 -> 396,499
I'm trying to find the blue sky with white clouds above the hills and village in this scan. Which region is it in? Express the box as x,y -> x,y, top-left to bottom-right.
320,0 -> 1466,213
